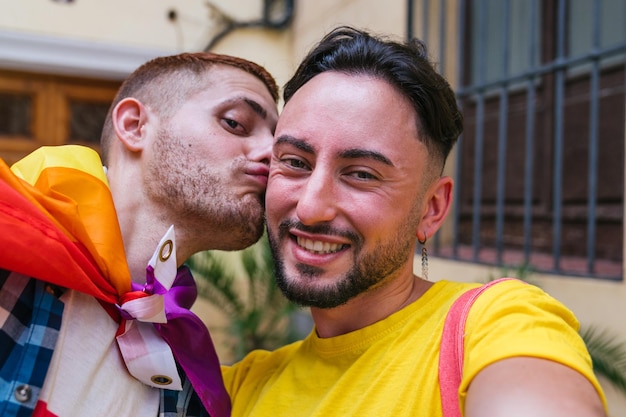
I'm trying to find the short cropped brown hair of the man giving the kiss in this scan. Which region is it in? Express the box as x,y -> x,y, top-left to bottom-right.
100,52 -> 278,165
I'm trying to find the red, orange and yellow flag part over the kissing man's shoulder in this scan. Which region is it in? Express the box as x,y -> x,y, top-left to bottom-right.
0,146 -> 130,302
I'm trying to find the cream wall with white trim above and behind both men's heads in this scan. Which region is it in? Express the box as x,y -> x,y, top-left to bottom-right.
0,0 -> 406,96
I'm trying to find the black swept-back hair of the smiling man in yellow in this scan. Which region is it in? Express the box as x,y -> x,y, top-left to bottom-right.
283,26 -> 463,167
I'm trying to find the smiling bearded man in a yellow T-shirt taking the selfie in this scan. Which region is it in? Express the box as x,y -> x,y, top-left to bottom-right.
223,27 -> 605,417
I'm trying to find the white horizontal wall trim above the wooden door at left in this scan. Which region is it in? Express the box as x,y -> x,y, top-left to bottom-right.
0,29 -> 175,80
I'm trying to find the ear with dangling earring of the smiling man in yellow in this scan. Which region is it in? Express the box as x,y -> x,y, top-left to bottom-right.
416,177 -> 453,241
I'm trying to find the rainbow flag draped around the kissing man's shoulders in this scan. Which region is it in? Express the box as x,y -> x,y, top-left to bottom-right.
0,145 -> 230,417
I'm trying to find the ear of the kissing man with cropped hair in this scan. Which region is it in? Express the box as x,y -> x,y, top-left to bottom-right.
112,97 -> 148,152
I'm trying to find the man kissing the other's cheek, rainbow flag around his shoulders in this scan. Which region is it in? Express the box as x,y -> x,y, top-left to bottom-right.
0,53 -> 278,417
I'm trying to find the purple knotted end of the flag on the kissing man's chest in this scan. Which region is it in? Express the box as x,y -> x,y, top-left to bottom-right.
132,266 -> 231,417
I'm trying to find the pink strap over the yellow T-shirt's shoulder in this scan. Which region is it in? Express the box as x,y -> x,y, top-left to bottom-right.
439,278 -> 513,417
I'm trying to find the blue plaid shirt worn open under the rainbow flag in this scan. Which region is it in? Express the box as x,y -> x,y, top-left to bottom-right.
0,269 -> 208,417
